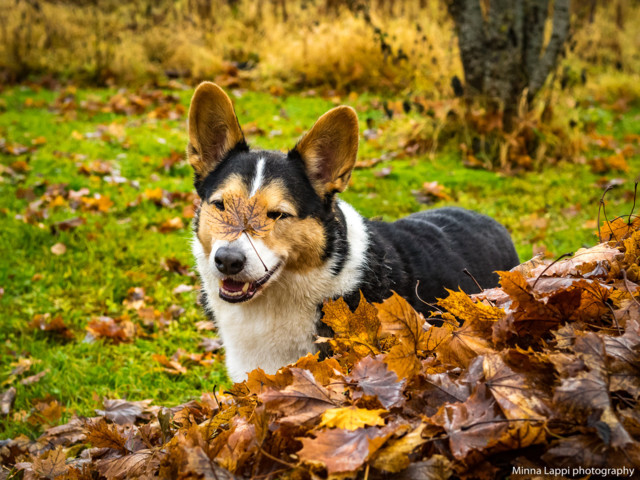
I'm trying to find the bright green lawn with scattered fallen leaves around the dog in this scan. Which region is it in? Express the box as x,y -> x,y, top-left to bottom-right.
0,87 -> 640,438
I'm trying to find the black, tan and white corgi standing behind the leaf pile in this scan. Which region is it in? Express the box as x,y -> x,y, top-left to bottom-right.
187,82 -> 519,382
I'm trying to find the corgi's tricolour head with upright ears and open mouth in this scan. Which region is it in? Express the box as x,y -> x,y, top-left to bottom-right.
187,82 -> 358,303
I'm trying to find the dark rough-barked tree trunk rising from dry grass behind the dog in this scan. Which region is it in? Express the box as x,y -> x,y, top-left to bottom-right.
448,0 -> 570,131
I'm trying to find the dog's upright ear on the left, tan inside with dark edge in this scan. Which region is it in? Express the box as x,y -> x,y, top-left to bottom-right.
187,82 -> 244,178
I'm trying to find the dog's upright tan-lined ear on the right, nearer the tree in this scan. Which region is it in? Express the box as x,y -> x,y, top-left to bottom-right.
293,106 -> 359,198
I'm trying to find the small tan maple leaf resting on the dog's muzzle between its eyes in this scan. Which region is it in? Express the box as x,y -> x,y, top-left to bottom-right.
210,195 -> 275,242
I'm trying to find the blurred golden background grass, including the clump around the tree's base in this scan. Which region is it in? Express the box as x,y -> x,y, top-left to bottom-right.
0,0 -> 640,171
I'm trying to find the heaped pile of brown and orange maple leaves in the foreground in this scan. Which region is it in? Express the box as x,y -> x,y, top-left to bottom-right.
0,216 -> 640,479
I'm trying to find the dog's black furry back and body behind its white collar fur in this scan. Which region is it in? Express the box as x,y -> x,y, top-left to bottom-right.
347,207 -> 519,312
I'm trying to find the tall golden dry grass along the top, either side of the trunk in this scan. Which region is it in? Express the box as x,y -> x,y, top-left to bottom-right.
0,0 -> 640,102
